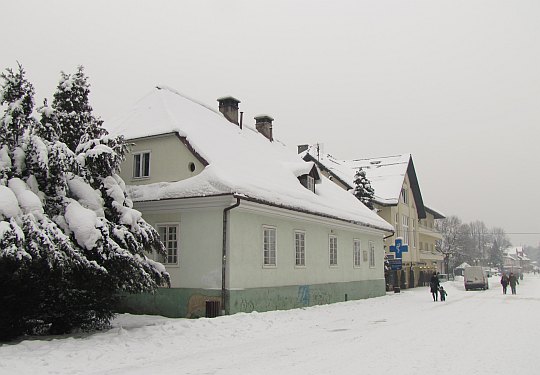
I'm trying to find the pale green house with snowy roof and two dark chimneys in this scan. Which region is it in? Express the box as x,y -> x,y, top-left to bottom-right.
106,87 -> 393,317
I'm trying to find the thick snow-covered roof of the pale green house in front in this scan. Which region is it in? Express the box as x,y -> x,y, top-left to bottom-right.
104,86 -> 393,231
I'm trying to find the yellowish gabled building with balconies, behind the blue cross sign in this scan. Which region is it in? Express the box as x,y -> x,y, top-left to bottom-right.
298,145 -> 444,287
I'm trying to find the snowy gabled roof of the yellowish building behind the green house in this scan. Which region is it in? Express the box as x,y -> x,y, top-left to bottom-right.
300,146 -> 426,219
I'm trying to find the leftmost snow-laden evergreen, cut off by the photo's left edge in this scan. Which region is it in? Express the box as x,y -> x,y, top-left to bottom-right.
0,65 -> 95,339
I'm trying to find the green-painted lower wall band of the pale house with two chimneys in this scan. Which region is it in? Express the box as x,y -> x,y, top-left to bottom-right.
118,279 -> 386,318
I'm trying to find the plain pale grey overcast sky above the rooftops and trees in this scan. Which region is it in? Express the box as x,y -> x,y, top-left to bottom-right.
4,0 -> 540,246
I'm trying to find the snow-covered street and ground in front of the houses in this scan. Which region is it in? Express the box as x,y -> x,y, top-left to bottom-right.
0,275 -> 540,375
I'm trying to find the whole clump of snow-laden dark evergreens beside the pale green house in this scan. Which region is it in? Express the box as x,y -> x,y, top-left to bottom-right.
0,66 -> 169,339
